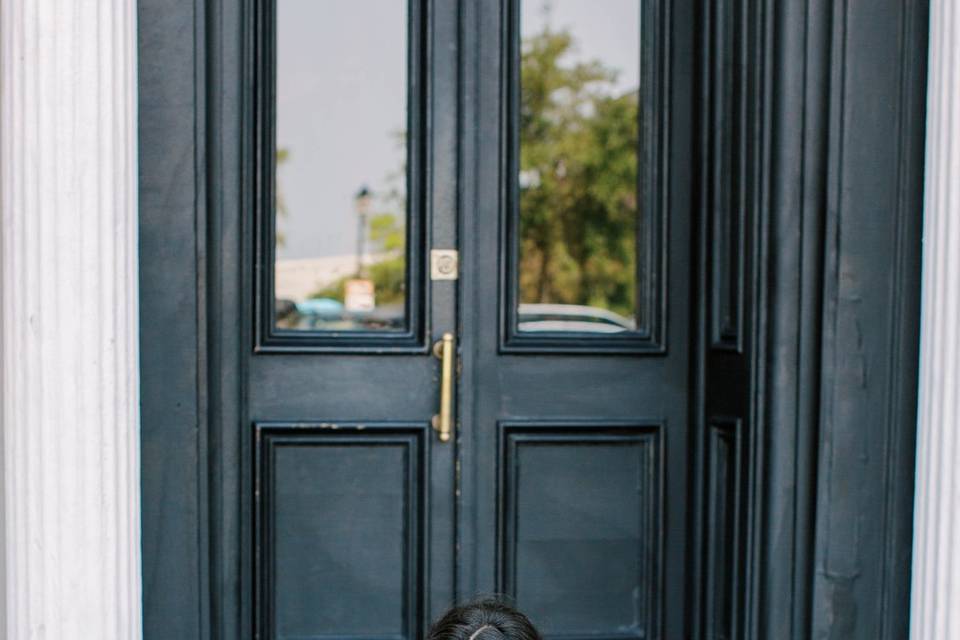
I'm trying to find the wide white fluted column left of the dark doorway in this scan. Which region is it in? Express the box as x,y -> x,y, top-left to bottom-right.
0,0 -> 141,640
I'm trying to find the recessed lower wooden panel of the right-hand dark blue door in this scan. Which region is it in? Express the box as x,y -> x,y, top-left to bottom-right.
501,424 -> 661,638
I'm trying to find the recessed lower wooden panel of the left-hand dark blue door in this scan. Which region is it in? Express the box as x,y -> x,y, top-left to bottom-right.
256,424 -> 427,638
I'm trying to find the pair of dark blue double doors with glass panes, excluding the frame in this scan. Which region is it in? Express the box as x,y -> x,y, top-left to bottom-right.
249,0 -> 691,638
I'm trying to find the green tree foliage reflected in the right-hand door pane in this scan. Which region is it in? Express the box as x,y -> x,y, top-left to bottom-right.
519,27 -> 639,317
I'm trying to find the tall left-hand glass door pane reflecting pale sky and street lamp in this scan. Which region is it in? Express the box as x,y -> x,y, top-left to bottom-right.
274,0 -> 407,331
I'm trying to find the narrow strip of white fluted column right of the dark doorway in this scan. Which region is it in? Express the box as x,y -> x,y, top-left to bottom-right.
910,0 -> 960,640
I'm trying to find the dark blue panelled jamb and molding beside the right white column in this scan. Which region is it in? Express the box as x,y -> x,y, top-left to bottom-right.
691,0 -> 927,639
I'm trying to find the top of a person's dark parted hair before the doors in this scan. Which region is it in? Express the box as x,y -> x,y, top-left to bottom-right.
427,598 -> 542,640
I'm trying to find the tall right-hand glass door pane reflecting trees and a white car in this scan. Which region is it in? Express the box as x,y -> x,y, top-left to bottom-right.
517,0 -> 640,333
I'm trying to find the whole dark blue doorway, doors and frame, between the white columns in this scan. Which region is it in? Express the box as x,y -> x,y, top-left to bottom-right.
138,0 -> 927,640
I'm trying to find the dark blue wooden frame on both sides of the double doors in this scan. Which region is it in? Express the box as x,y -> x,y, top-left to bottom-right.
139,0 -> 927,639
